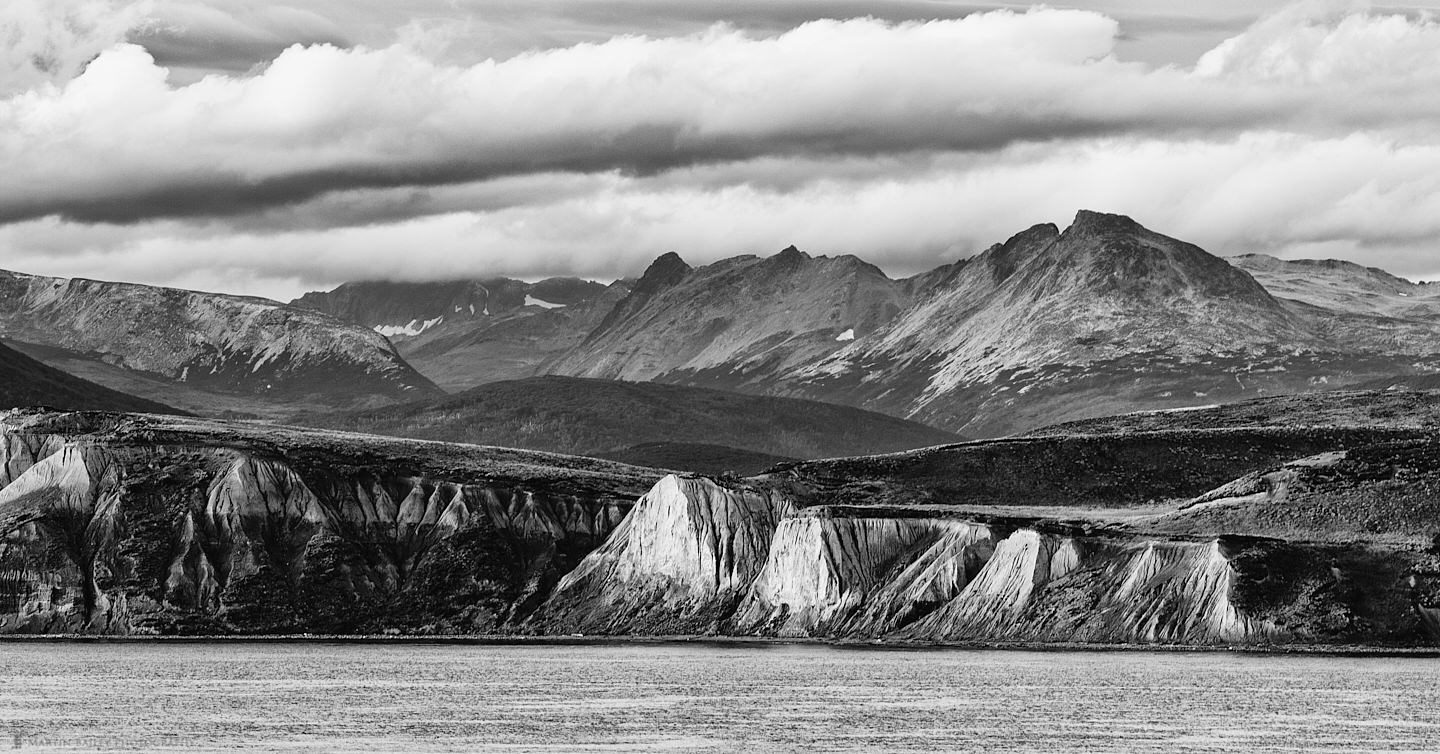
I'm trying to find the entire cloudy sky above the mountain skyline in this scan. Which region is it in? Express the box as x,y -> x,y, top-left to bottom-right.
0,0 -> 1440,301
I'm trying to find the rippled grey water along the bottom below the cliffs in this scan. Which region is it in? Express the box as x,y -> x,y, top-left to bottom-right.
0,642 -> 1440,753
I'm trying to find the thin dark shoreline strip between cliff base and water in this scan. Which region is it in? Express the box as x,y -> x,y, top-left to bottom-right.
0,633 -> 1440,658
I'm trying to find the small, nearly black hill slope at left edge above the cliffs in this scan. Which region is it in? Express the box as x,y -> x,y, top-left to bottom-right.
0,339 -> 180,413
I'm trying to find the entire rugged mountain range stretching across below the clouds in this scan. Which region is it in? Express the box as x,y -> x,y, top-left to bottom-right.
0,212 -> 1440,443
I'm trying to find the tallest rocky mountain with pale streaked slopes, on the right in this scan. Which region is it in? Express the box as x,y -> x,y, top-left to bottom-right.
770,212 -> 1440,436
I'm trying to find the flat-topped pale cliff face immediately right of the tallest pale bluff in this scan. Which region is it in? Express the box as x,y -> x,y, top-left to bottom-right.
736,511 -> 981,636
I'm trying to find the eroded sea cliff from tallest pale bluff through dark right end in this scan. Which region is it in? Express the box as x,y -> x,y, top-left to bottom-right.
527,476 -> 1434,645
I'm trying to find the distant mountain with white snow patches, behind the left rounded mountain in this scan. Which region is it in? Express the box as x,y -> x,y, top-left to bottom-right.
292,278 -> 629,390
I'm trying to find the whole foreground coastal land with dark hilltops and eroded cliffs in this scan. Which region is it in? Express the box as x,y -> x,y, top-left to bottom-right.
0,402 -> 1440,646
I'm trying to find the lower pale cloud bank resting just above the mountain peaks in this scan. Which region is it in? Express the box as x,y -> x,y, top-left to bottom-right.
8,132 -> 1440,298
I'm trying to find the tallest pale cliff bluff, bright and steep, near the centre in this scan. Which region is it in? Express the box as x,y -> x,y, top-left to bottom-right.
538,475 -> 792,633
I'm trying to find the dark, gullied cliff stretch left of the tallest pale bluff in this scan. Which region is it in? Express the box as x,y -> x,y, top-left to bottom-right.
0,416 -> 652,633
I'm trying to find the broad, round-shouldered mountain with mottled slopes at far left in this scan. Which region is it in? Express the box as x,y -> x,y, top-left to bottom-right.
0,271 -> 438,413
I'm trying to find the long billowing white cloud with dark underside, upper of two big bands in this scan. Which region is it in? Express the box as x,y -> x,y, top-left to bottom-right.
0,10 -> 1296,222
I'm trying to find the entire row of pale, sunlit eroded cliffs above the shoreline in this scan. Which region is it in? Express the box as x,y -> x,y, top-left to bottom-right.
544,503 -> 1286,645
